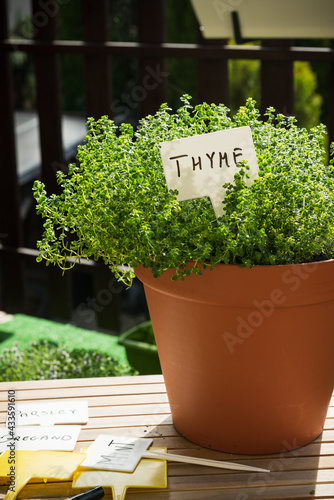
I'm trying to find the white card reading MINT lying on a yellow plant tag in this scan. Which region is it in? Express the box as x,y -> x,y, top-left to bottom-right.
80,434 -> 152,472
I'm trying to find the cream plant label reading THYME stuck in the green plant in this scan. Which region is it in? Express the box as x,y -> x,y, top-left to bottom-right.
160,127 -> 259,218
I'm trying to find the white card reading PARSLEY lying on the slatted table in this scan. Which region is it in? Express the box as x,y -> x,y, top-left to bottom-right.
7,399 -> 88,426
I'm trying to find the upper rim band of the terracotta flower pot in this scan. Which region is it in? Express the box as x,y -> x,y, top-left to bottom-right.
134,259 -> 334,308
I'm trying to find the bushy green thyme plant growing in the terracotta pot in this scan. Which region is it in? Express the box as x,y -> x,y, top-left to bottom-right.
34,95 -> 334,284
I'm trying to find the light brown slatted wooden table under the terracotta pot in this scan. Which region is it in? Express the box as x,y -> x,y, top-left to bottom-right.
0,375 -> 334,500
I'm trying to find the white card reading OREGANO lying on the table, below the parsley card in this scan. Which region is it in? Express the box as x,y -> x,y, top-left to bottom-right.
0,425 -> 81,452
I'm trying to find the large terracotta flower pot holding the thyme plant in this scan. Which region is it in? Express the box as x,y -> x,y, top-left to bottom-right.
136,260 -> 334,454
